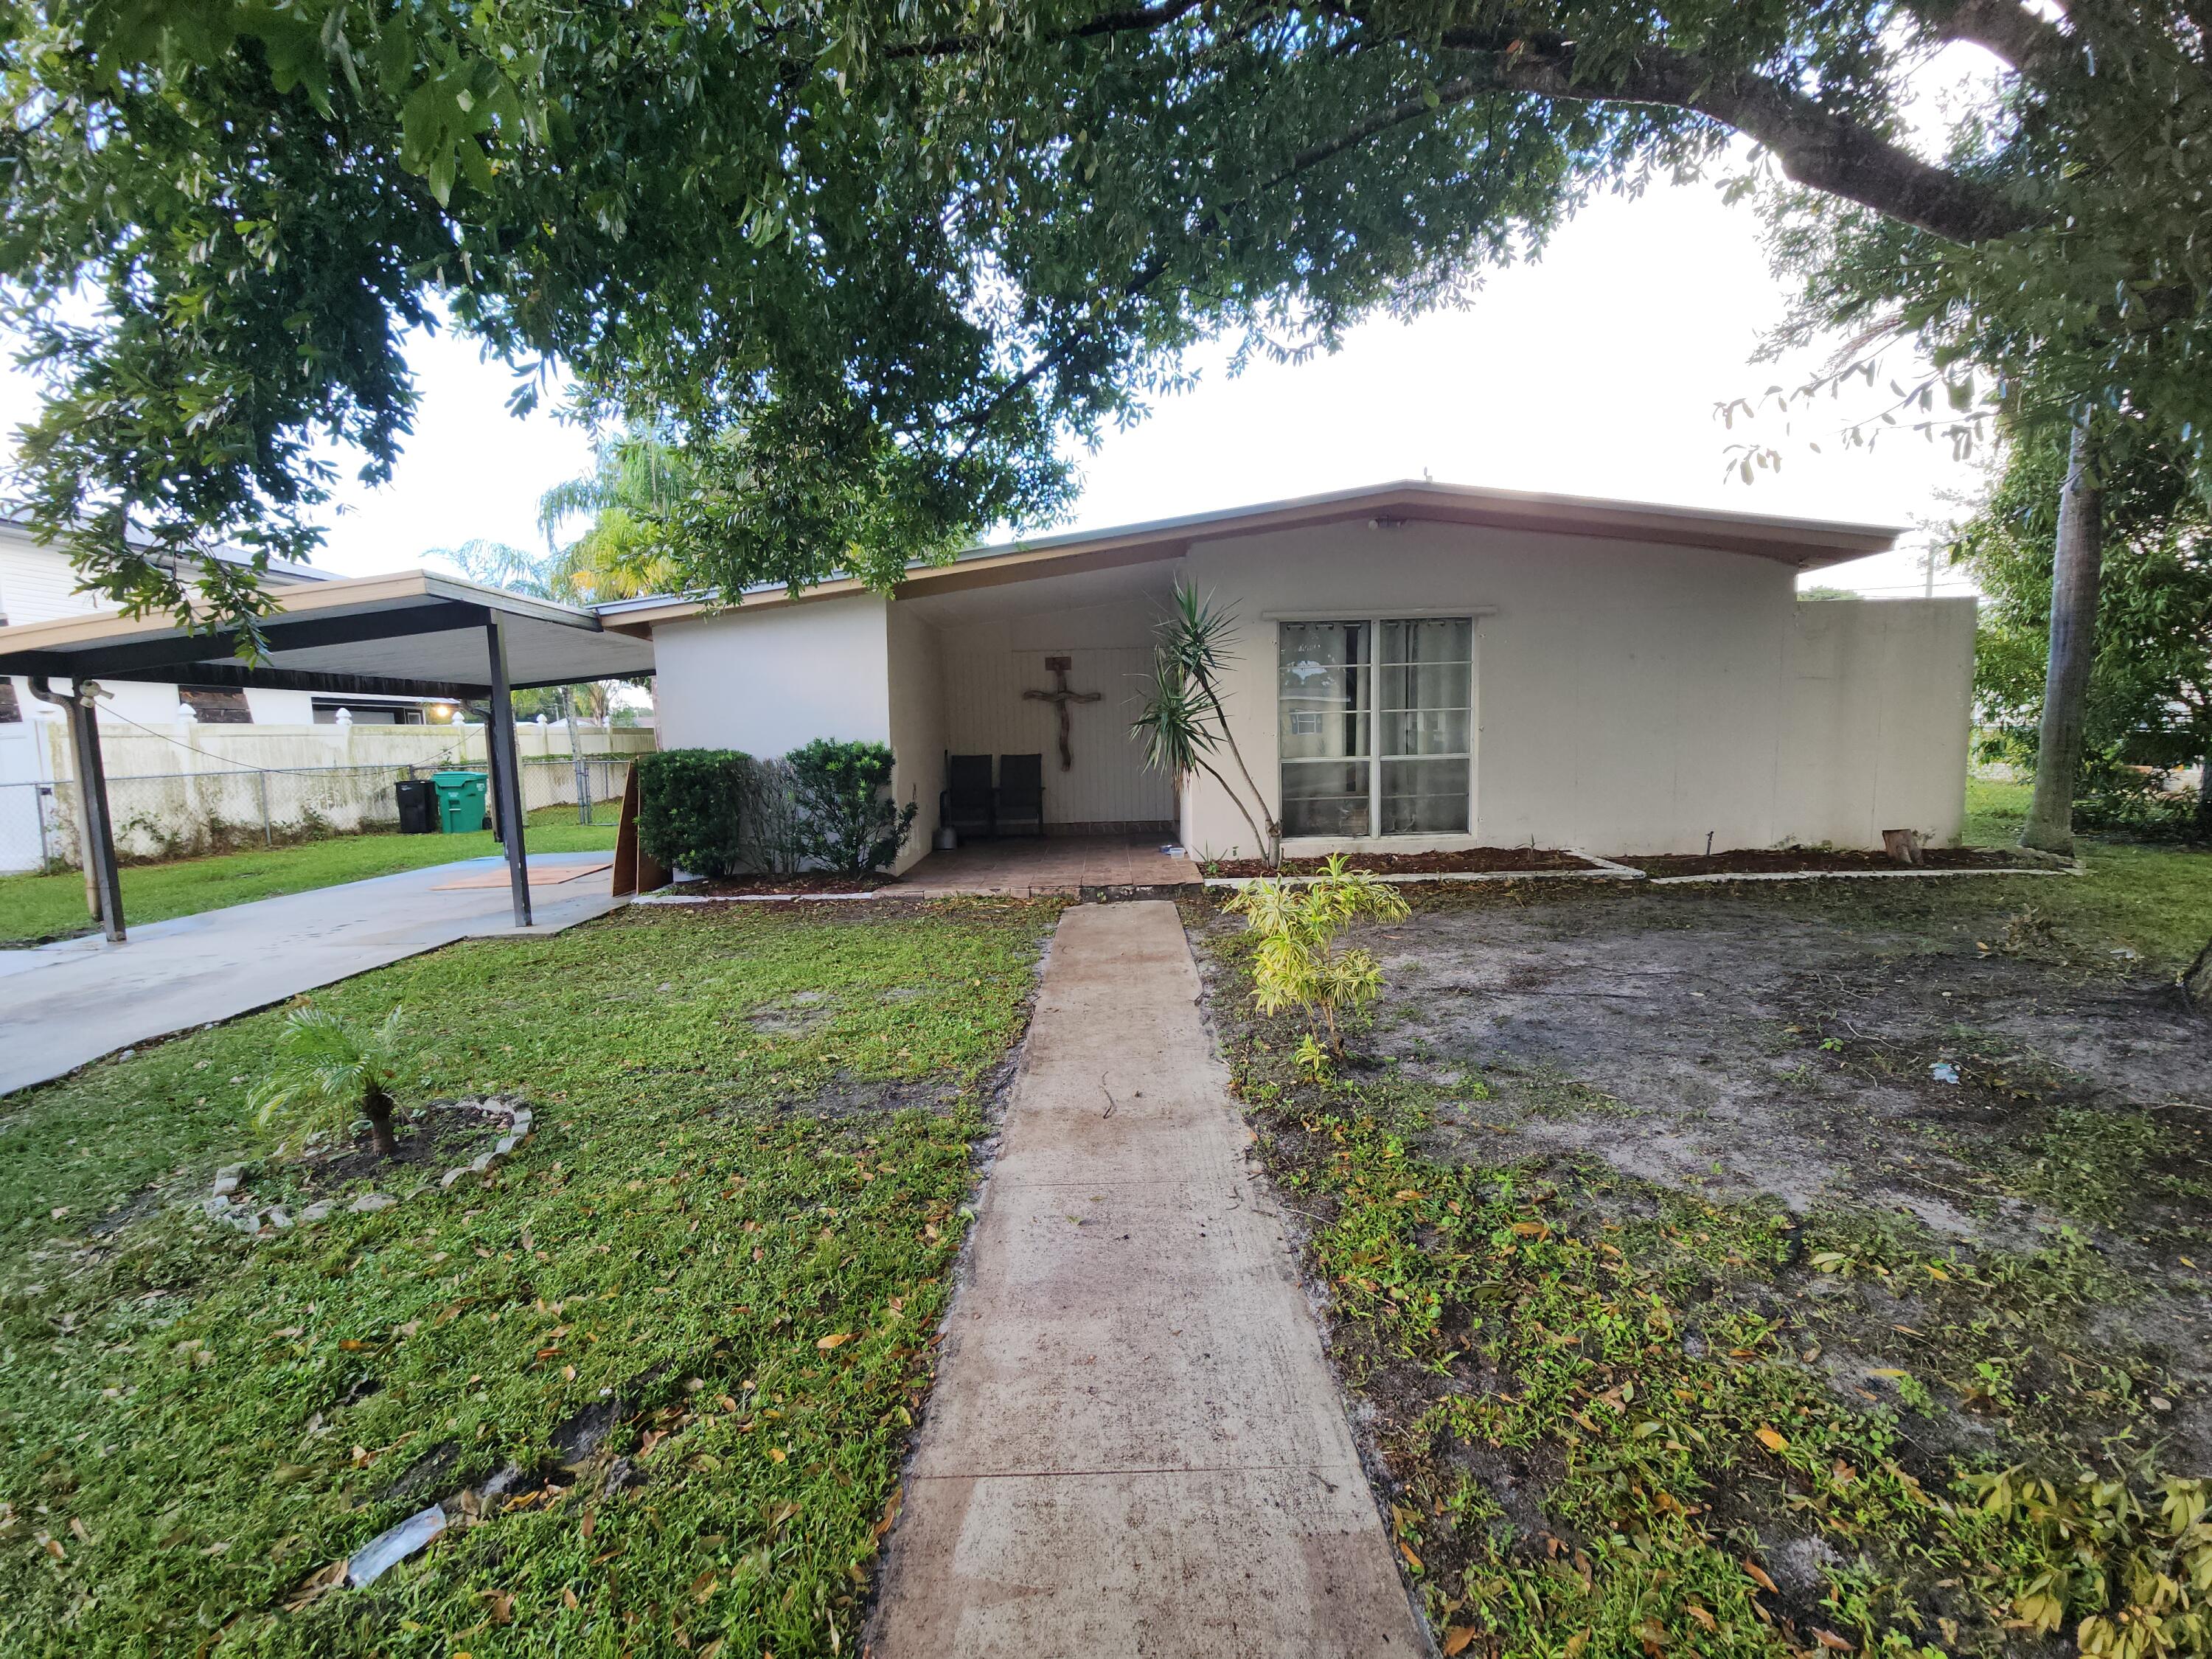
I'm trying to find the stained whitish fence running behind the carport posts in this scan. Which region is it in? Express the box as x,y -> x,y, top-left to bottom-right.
0,754 -> 633,872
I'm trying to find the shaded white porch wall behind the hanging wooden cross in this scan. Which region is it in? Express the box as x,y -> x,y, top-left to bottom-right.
942,599 -> 1175,825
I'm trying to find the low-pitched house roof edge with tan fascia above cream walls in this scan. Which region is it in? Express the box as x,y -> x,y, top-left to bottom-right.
595,480 -> 1905,633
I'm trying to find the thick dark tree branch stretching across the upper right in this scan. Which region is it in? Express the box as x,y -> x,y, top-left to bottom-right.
1442,29 -> 2028,243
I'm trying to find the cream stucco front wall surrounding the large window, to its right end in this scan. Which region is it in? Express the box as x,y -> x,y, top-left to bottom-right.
1183,522 -> 1971,854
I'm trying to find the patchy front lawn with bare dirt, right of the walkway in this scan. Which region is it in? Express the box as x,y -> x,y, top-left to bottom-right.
1186,845 -> 2212,1659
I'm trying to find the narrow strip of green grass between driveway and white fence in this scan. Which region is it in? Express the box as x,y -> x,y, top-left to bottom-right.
0,807 -> 615,945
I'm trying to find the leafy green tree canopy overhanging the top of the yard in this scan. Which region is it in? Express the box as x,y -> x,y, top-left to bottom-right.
0,0 -> 2212,628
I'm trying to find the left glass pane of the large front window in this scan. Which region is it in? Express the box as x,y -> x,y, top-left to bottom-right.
1276,622 -> 1374,836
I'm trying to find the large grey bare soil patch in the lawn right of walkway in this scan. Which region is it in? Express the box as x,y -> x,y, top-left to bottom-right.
1371,883 -> 2212,1473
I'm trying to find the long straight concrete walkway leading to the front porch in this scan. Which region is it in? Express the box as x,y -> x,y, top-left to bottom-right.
872,902 -> 1427,1659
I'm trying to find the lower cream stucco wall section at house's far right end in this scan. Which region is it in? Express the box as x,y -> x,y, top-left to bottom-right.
1778,599 -> 1975,847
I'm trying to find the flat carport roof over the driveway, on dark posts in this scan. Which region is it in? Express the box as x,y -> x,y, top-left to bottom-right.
0,571 -> 653,697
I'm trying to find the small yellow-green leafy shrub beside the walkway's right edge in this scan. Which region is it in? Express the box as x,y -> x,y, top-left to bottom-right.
1230,854 -> 1407,1082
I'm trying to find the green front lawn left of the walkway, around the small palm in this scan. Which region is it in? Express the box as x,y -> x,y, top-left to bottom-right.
0,902 -> 1055,1659
